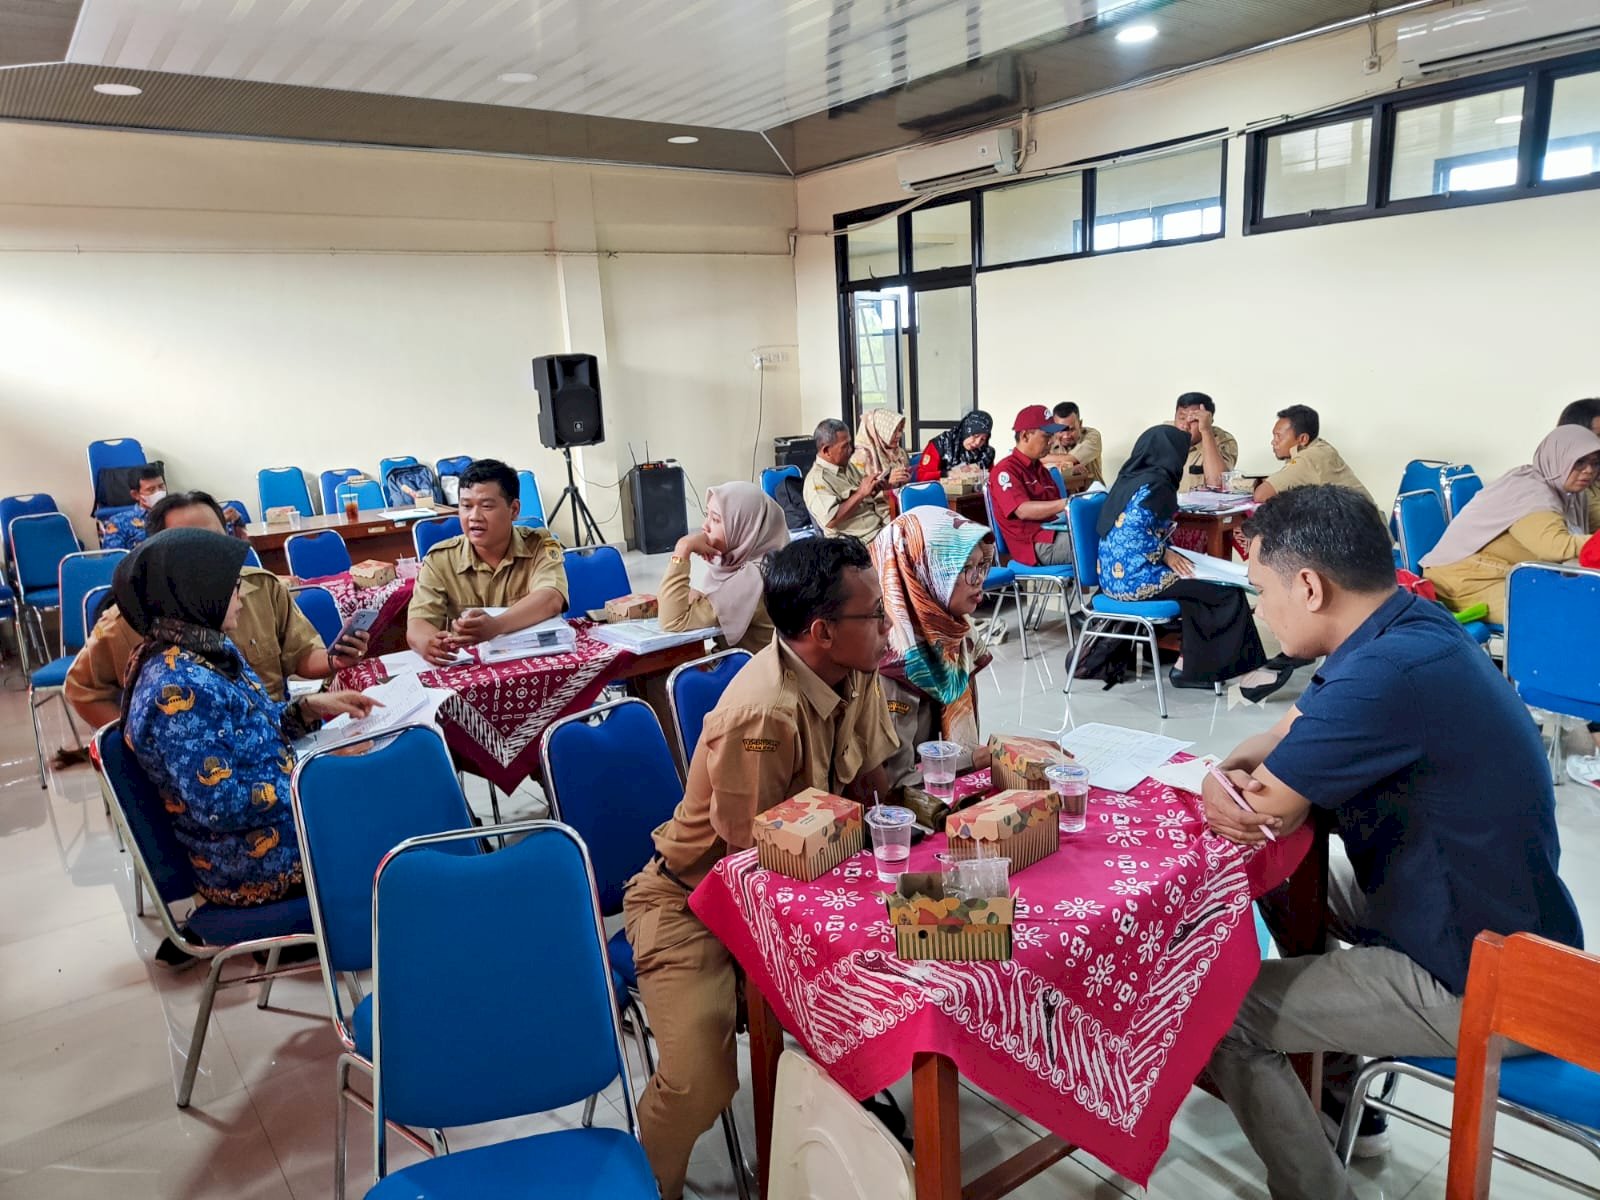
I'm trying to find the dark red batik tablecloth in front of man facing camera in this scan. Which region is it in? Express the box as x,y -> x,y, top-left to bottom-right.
339,621 -> 632,792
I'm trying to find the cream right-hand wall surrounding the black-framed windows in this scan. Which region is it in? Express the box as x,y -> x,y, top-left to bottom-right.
795,10 -> 1600,502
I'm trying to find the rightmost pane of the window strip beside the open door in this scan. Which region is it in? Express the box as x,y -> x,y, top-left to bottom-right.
1094,144 -> 1222,250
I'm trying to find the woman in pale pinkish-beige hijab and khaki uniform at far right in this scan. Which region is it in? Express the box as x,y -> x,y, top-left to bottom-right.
1422,426 -> 1600,624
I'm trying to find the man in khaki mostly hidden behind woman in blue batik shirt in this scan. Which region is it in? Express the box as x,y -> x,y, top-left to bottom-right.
62,491 -> 366,728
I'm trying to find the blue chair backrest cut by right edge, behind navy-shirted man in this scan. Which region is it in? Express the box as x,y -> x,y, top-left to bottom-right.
1506,563 -> 1600,722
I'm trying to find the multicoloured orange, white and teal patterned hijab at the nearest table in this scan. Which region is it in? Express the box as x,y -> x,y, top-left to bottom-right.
872,506 -> 994,747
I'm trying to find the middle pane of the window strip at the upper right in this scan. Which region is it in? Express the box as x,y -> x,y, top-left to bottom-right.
1389,88 -> 1522,200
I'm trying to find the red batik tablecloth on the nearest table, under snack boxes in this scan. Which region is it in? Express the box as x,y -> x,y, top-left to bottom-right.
690,779 -> 1310,1184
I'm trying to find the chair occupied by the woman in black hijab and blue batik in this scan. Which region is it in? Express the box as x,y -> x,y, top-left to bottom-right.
94,722 -> 317,1109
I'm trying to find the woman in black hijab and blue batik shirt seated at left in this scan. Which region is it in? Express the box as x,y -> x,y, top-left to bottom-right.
112,528 -> 374,907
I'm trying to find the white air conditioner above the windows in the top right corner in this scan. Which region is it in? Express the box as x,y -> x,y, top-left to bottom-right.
1398,0 -> 1600,78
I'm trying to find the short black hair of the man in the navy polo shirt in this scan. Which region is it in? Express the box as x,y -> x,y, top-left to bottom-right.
1245,483 -> 1395,592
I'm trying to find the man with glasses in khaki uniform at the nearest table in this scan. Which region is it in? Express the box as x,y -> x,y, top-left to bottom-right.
624,538 -> 898,1200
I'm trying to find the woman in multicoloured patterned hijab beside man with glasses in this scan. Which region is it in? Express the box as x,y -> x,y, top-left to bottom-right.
872,506 -> 995,787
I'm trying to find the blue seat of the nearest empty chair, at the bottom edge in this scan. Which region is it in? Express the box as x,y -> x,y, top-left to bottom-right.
366,1130 -> 661,1200
